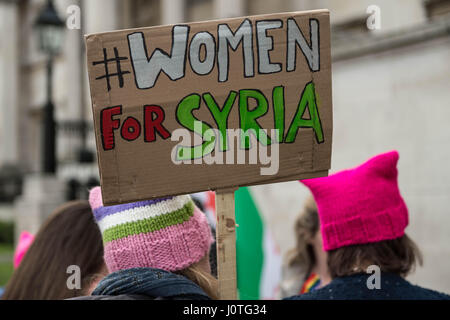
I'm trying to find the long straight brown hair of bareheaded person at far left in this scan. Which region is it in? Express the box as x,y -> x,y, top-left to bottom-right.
2,201 -> 104,300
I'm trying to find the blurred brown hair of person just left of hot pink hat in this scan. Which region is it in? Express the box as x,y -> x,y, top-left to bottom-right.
288,196 -> 319,275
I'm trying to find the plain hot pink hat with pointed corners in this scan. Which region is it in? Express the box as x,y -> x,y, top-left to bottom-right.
301,151 -> 408,251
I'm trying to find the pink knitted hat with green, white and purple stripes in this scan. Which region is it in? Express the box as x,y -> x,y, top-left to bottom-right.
89,187 -> 214,272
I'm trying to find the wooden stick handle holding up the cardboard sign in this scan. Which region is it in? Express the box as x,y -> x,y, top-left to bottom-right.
216,189 -> 237,300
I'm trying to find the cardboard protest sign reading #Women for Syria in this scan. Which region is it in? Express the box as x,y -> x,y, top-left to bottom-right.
86,10 -> 332,205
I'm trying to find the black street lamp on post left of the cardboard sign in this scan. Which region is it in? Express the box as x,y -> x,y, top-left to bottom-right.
35,0 -> 65,174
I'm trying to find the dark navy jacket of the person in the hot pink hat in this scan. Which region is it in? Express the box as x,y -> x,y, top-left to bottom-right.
287,273 -> 450,300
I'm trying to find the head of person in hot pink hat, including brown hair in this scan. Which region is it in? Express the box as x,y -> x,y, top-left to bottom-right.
302,151 -> 421,277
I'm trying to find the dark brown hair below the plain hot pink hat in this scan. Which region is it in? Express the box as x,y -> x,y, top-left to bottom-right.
328,234 -> 423,278
